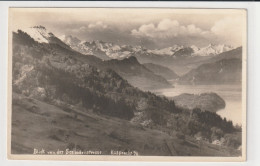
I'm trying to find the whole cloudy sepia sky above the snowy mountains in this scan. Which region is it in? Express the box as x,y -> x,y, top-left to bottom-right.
10,8 -> 246,48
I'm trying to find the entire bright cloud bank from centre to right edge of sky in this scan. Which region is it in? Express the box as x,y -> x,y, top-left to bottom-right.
131,15 -> 245,46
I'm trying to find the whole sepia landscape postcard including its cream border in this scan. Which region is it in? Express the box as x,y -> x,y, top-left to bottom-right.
8,8 -> 247,161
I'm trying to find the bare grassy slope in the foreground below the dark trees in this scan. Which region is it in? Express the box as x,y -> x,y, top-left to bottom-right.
12,93 -> 241,156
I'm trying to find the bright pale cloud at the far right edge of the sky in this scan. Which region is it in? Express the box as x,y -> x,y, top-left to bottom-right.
211,16 -> 245,46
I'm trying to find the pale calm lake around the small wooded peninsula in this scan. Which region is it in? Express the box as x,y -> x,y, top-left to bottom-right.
152,85 -> 242,125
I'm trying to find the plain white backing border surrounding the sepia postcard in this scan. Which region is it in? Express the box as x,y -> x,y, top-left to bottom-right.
0,1 -> 260,166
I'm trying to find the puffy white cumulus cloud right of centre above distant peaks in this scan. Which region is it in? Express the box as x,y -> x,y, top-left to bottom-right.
131,19 -> 210,38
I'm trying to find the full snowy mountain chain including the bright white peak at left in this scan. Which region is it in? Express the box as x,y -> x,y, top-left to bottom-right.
18,25 -> 234,60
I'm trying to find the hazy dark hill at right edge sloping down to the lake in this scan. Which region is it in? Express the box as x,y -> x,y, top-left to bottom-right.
178,47 -> 242,85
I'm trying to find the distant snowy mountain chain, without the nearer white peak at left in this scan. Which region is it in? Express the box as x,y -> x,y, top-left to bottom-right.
60,35 -> 234,60
